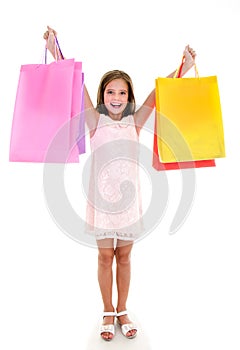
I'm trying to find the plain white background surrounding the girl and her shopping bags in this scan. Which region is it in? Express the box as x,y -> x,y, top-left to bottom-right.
0,0 -> 240,350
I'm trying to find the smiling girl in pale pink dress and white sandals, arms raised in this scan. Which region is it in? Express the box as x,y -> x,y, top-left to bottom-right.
44,27 -> 196,341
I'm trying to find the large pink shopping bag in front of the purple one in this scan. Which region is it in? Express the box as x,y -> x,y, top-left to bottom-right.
9,37 -> 82,163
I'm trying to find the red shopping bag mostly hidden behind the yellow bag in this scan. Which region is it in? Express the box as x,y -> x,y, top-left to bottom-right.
152,111 -> 216,171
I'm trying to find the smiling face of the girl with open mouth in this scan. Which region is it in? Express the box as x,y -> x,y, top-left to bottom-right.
104,79 -> 128,119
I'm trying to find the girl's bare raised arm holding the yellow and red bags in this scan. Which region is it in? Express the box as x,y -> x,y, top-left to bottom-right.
134,45 -> 196,133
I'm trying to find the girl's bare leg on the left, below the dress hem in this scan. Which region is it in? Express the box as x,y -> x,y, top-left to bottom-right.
98,239 -> 115,339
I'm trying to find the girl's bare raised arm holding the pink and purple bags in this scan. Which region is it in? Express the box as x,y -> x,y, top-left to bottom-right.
43,26 -> 99,132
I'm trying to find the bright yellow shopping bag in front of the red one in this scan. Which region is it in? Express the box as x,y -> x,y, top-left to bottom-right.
155,59 -> 225,163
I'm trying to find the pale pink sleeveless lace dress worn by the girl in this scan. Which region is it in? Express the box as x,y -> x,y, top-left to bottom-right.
86,114 -> 143,241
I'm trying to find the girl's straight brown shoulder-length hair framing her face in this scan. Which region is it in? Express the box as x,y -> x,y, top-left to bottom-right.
96,70 -> 136,117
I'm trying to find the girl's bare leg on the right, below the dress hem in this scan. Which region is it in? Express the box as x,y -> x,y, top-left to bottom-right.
115,240 -> 136,336
